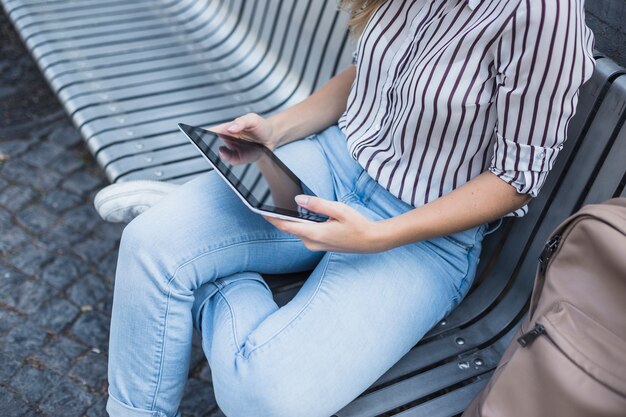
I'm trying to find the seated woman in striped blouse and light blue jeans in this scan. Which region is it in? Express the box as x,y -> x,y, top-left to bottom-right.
107,0 -> 594,417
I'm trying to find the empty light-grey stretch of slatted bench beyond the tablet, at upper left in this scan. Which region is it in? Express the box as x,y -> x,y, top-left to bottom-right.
4,0 -> 351,182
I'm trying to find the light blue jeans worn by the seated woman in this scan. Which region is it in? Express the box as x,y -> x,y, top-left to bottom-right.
107,126 -> 487,417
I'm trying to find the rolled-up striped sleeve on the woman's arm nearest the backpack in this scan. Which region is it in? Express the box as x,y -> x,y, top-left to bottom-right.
489,0 -> 595,216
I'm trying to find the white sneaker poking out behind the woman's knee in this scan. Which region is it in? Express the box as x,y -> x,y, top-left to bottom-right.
93,180 -> 178,223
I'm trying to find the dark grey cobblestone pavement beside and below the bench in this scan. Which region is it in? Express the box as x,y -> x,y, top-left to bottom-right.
0,8 -> 222,417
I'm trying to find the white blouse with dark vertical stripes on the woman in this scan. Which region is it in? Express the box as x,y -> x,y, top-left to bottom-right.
339,0 -> 595,216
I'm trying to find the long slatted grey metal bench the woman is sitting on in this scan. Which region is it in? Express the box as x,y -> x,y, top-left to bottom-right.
0,0 -> 626,417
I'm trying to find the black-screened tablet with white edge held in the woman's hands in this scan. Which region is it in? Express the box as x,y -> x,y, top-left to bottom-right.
178,123 -> 328,222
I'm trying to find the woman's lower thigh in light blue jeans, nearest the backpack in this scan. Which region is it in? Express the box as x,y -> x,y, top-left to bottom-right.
211,239 -> 471,416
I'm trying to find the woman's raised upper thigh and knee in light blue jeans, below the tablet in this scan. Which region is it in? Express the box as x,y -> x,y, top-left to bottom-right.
120,168 -> 321,293
